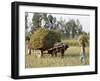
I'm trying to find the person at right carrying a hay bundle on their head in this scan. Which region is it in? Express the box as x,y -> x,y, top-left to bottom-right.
79,33 -> 88,64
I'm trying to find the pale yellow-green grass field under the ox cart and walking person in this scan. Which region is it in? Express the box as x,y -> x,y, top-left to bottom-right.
25,46 -> 89,68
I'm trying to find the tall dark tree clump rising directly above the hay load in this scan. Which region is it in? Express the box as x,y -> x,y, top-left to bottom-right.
32,13 -> 57,32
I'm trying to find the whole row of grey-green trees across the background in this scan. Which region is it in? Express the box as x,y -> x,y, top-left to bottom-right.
25,12 -> 89,39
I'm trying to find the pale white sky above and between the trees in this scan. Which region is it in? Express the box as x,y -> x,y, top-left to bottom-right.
28,13 -> 90,32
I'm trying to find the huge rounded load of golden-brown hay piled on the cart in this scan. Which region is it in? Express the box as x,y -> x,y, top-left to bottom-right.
31,28 -> 61,49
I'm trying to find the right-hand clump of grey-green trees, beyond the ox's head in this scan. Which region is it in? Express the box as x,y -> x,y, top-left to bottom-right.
58,18 -> 82,38
